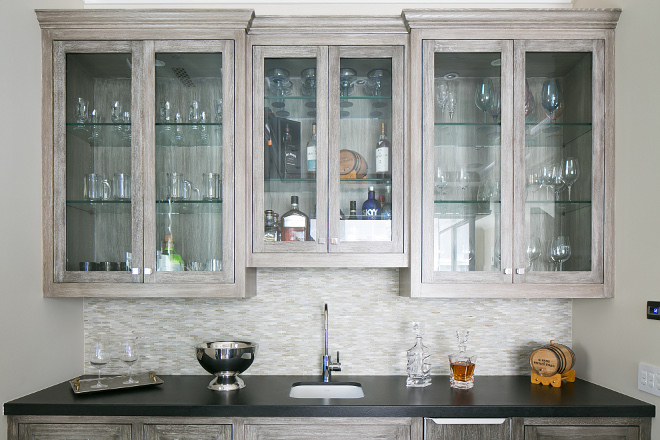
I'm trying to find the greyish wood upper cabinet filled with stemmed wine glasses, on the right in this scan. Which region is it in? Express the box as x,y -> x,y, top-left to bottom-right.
401,10 -> 620,297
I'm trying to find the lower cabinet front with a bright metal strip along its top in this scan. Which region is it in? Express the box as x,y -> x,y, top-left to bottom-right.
424,419 -> 511,440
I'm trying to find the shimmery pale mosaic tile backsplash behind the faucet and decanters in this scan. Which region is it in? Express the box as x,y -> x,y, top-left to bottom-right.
84,269 -> 572,375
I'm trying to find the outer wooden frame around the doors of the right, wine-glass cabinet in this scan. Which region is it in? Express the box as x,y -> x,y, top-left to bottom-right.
399,9 -> 621,298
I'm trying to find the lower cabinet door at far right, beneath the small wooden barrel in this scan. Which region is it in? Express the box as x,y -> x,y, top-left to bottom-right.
525,426 -> 639,440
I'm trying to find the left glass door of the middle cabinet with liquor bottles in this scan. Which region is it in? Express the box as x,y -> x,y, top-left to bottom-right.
252,46 -> 328,252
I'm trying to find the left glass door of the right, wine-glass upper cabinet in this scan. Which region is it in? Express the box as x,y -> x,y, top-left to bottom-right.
422,41 -> 513,283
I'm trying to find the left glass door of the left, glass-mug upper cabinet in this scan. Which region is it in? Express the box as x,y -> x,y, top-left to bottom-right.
52,41 -> 143,283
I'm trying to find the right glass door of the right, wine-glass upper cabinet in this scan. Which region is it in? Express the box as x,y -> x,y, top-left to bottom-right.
514,40 -> 612,284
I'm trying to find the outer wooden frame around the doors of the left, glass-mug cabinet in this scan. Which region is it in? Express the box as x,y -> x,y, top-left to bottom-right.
36,9 -> 256,298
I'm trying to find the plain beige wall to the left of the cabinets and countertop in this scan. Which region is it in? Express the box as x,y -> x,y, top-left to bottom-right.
0,0 -> 83,439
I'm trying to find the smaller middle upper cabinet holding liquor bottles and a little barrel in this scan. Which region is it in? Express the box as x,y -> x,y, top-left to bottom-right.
248,17 -> 408,267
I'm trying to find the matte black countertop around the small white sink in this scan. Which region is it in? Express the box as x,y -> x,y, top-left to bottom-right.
4,375 -> 655,417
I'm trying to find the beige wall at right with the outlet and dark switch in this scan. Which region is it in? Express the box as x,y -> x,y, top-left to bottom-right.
573,0 -> 660,439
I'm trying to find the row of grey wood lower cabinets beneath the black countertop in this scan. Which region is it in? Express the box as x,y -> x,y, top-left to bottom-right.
7,416 -> 651,440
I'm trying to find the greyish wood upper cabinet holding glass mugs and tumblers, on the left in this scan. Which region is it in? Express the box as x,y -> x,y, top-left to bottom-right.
38,11 -> 254,297
